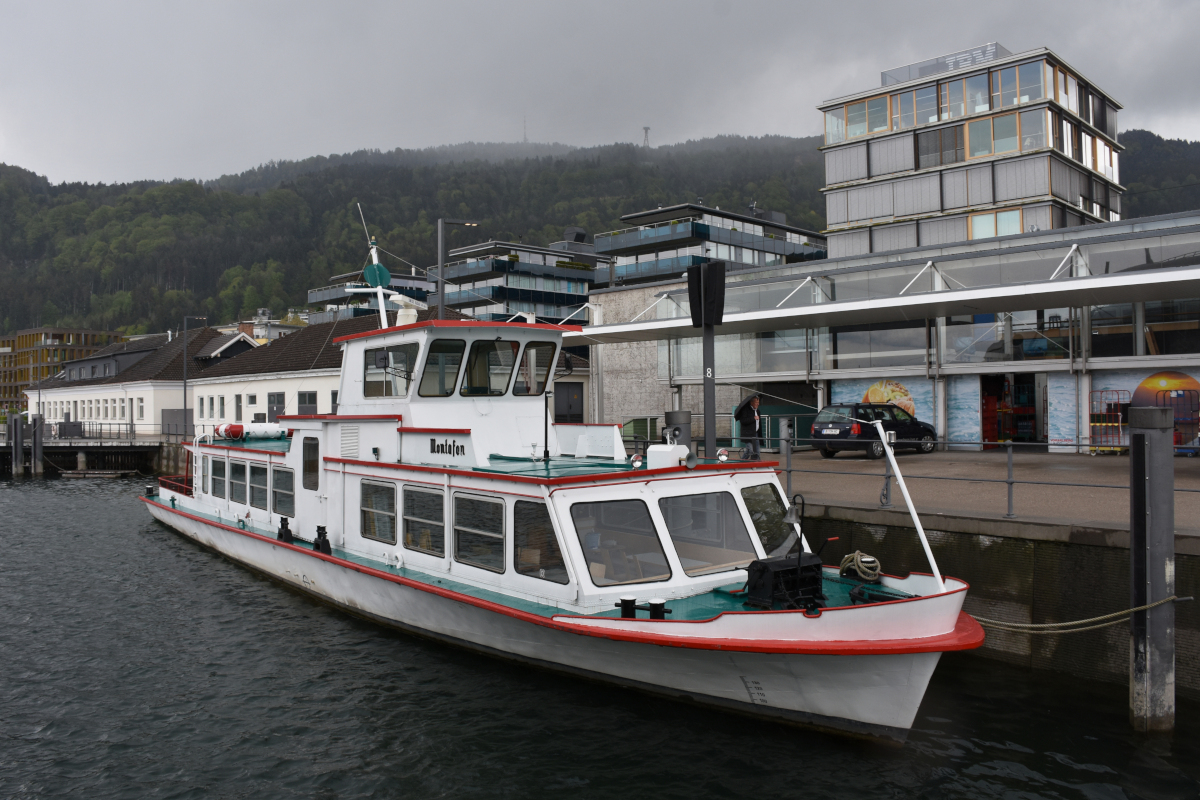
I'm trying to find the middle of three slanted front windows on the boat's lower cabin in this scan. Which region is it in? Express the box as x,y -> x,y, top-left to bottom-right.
659,492 -> 758,576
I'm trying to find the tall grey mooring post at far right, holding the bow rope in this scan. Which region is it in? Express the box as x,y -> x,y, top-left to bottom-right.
1129,408 -> 1175,732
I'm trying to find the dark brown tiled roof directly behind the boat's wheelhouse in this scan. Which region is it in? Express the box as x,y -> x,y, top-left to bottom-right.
194,308 -> 470,378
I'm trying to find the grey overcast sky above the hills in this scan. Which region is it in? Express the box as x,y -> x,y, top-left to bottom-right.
0,0 -> 1200,182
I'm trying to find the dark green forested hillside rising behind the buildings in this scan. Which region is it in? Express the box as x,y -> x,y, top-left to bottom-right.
0,131 -> 1200,332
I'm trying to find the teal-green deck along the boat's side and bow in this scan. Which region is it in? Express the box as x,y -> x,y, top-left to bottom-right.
159,496 -> 912,621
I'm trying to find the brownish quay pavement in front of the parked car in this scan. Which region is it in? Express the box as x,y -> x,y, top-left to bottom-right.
763,447 -> 1200,534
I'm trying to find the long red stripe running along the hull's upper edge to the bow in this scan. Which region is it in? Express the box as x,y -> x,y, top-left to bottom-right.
139,497 -> 984,656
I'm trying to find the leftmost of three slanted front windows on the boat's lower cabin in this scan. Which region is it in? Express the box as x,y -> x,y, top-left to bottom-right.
571,500 -> 671,587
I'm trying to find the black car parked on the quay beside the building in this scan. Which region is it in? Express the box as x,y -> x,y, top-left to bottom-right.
812,403 -> 937,458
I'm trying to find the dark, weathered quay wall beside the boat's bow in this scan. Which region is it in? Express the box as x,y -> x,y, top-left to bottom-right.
804,504 -> 1200,698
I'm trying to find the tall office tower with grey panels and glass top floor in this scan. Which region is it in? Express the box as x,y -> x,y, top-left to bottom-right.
820,42 -> 1123,258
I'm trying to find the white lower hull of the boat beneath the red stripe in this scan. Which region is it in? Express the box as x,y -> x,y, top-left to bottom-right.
145,499 -> 955,740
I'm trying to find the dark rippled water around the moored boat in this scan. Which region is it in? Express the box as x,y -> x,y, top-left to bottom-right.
0,481 -> 1200,800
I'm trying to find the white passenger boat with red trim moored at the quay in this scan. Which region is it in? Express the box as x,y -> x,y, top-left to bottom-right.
143,321 -> 983,736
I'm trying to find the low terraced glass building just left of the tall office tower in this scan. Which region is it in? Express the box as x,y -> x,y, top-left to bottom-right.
595,203 -> 826,285
